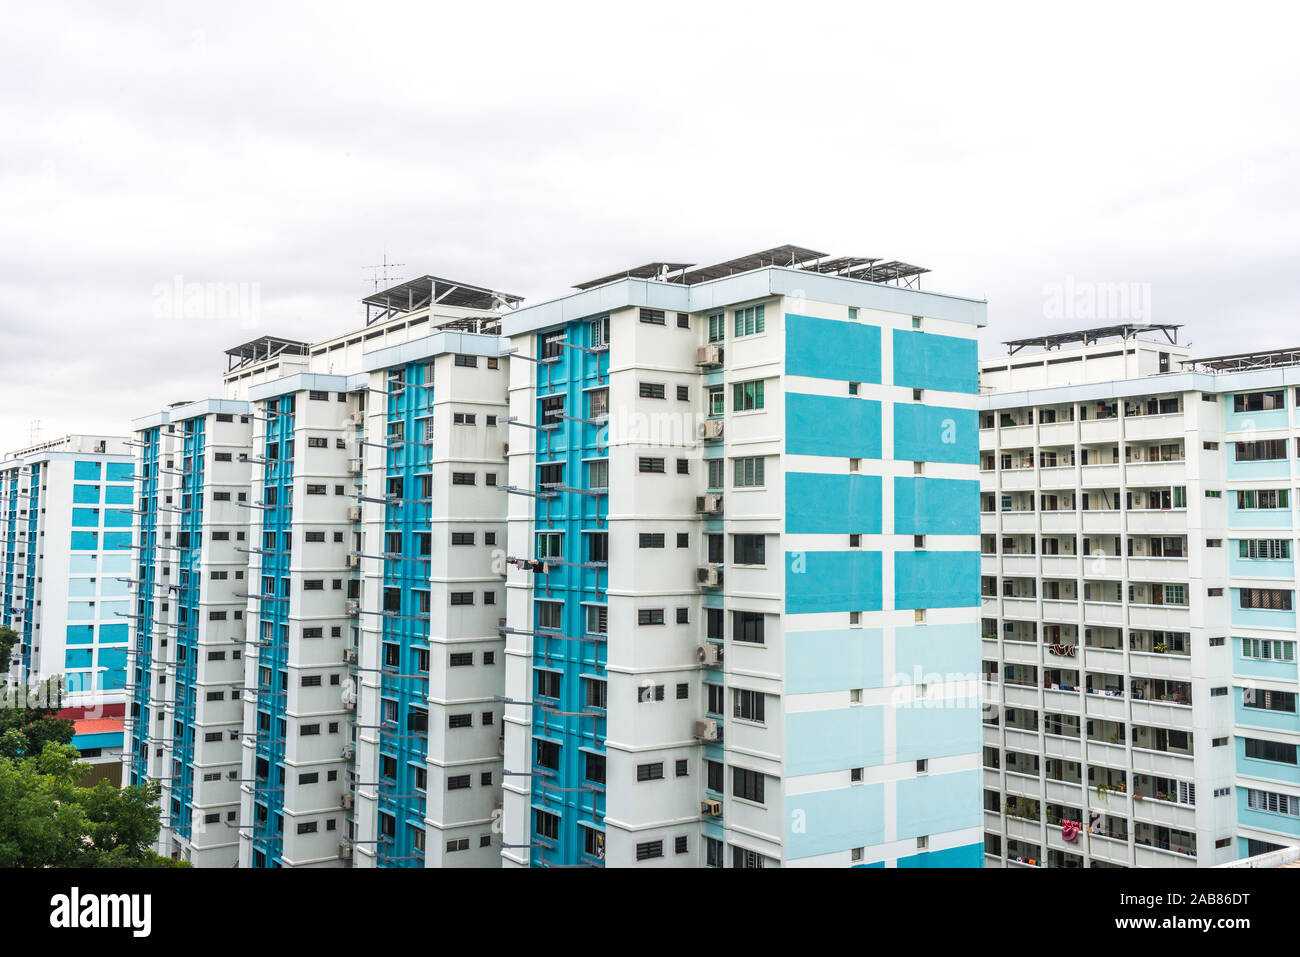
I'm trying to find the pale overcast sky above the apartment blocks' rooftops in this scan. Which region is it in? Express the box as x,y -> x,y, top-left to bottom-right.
0,0 -> 1300,452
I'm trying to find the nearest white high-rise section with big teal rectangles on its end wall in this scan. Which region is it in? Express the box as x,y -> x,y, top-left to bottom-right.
502,247 -> 985,867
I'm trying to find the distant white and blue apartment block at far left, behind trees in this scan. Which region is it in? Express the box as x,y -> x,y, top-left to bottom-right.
0,436 -> 133,702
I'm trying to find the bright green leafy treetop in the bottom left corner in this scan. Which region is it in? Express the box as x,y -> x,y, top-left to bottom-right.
0,741 -> 189,867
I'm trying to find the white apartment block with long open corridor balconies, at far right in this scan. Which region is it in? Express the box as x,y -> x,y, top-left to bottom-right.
979,325 -> 1300,867
